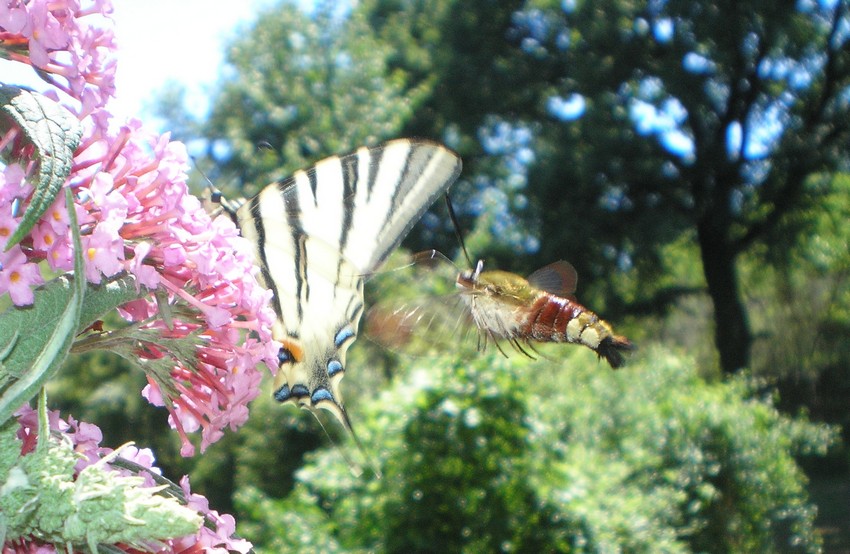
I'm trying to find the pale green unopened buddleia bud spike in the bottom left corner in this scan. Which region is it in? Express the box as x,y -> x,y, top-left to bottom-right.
0,422 -> 201,552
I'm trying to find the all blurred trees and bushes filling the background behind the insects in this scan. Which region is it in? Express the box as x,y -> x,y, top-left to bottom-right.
52,0 -> 850,552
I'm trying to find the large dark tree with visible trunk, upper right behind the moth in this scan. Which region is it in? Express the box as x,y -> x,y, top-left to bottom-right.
364,0 -> 850,372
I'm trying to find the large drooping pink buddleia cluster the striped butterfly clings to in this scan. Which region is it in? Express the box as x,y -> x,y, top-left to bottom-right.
66,118 -> 277,455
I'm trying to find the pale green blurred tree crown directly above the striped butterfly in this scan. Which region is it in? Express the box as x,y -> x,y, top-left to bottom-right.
200,2 -> 424,187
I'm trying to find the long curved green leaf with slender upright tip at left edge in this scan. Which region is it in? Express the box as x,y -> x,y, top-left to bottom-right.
0,189 -> 86,425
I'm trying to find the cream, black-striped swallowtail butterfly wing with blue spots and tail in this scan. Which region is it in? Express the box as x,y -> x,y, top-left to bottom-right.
237,139 -> 461,431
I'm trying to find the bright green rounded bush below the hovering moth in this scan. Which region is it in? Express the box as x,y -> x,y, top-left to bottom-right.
238,348 -> 834,552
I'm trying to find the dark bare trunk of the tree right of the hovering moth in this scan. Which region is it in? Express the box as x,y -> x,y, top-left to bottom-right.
697,220 -> 752,373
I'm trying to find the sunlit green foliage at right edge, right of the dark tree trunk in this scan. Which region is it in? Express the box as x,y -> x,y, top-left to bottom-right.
742,173 -> 850,380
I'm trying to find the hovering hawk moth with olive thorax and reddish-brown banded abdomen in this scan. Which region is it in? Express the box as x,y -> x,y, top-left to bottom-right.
457,262 -> 633,368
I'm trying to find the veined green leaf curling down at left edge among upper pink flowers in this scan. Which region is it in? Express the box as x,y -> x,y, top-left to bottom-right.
0,85 -> 83,250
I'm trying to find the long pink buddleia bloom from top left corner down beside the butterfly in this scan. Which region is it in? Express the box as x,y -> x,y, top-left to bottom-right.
0,0 -> 278,455
